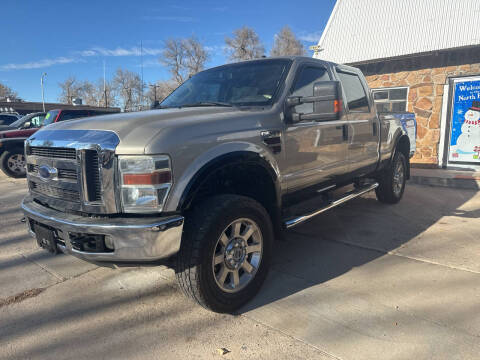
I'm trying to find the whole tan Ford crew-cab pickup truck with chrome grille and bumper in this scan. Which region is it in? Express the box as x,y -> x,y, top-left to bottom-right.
22,57 -> 415,312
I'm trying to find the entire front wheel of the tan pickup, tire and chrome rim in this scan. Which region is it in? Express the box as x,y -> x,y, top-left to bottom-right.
175,195 -> 273,313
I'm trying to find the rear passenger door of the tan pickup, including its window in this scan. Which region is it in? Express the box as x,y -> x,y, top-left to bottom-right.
336,66 -> 380,177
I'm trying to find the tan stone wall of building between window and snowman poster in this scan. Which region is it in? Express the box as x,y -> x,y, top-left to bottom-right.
366,63 -> 480,164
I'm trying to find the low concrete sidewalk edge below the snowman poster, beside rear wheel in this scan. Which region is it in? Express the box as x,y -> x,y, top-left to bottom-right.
410,168 -> 480,190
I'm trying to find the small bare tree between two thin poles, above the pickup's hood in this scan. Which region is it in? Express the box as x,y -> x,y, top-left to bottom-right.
112,68 -> 145,111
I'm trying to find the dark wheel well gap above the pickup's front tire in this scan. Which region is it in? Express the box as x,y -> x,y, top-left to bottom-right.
181,159 -> 279,223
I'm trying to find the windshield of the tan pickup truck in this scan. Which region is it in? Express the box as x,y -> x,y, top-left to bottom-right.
160,59 -> 291,107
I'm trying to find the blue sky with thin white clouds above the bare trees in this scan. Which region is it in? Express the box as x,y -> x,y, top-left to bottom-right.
0,0 -> 335,102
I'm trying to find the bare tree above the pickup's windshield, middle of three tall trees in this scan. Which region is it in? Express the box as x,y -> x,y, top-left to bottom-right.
225,26 -> 265,61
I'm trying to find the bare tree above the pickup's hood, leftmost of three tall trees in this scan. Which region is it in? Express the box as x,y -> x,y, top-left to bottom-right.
160,36 -> 208,85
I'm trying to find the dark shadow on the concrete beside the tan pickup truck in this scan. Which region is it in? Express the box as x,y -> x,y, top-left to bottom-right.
239,184 -> 480,313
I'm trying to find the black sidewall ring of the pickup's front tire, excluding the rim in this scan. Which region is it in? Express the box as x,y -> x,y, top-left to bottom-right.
194,200 -> 273,307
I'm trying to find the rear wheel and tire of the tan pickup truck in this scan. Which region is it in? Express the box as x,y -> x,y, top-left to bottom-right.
375,151 -> 407,204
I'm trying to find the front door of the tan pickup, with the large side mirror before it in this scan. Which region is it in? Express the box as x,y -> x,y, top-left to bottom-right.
285,64 -> 348,192
